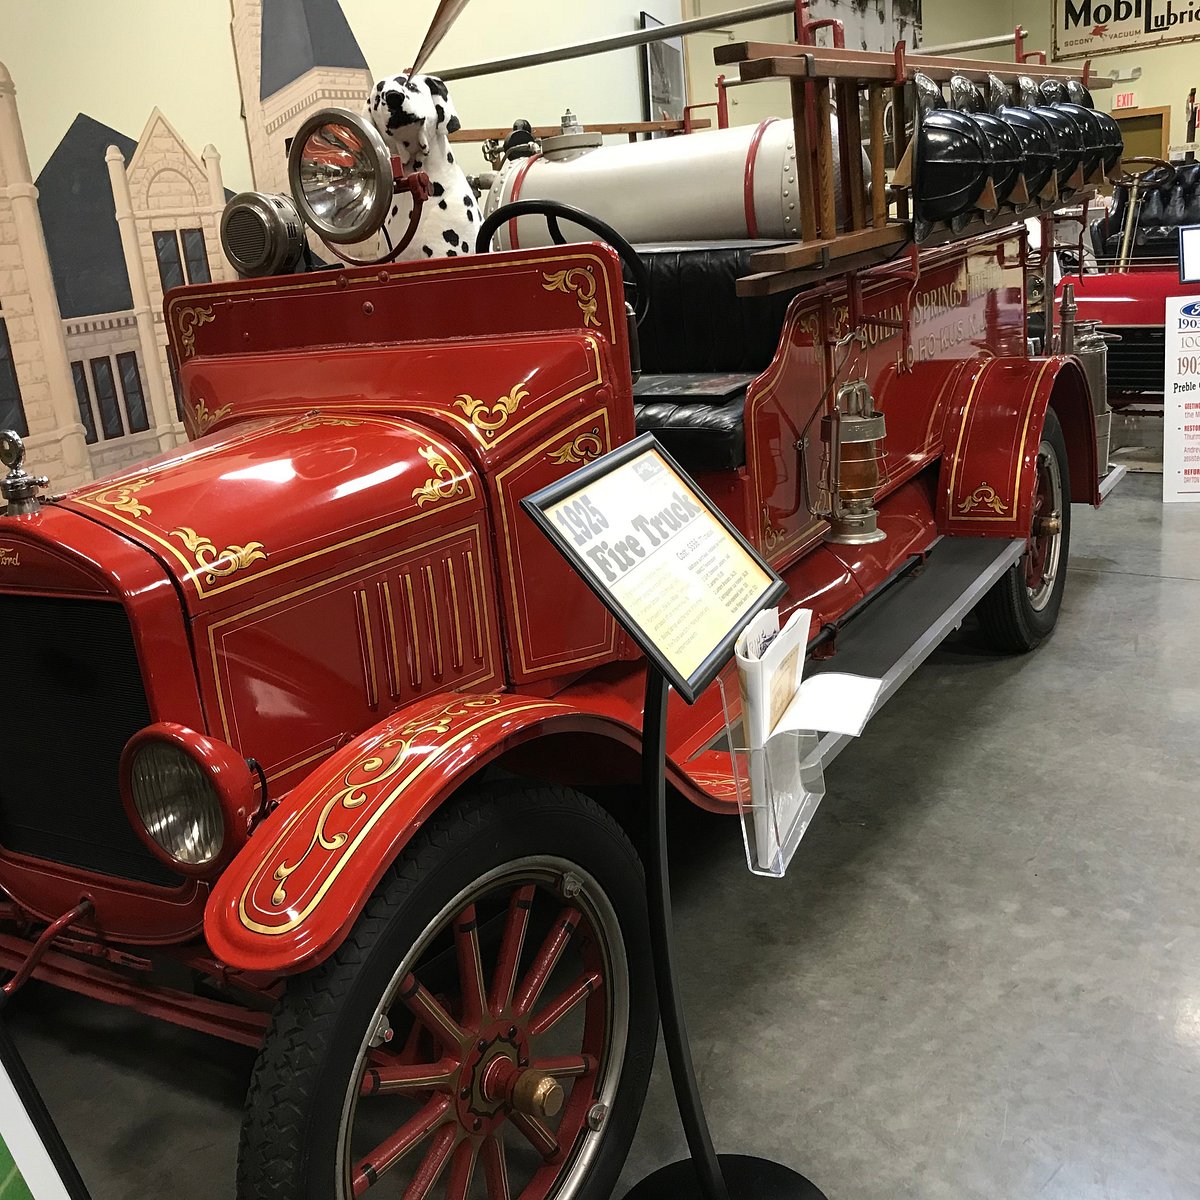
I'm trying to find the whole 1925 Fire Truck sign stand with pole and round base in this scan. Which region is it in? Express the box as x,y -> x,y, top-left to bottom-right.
521,434 -> 826,1200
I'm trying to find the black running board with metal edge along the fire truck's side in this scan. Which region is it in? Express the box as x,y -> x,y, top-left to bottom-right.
806,538 -> 1026,767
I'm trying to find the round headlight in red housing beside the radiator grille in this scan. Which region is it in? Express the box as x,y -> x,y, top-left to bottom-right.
121,725 -> 256,875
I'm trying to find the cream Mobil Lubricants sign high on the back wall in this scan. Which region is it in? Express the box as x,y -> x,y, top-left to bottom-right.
1054,0 -> 1200,59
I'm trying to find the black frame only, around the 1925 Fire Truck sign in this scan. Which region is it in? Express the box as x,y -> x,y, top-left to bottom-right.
521,433 -> 787,704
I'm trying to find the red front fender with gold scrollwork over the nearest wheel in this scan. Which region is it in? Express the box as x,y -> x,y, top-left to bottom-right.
204,694 -> 611,974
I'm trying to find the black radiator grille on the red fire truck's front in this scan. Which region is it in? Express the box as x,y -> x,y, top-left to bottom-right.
0,595 -> 181,887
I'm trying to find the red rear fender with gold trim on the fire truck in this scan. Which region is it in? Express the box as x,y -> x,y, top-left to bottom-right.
937,355 -> 1100,538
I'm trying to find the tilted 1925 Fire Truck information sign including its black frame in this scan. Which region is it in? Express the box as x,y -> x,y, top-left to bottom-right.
521,434 -> 787,704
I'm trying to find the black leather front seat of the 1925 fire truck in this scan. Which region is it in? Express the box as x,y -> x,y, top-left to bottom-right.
634,241 -> 790,472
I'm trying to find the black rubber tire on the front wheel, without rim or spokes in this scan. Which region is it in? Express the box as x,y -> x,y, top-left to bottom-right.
236,780 -> 658,1200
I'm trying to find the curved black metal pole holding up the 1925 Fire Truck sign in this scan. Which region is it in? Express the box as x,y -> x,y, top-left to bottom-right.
642,664 -> 730,1200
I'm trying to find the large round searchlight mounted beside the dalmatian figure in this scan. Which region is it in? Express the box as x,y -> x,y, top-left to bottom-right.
288,108 -> 395,246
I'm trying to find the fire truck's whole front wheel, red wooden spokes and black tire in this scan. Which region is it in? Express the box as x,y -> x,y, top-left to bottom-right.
239,786 -> 658,1200
